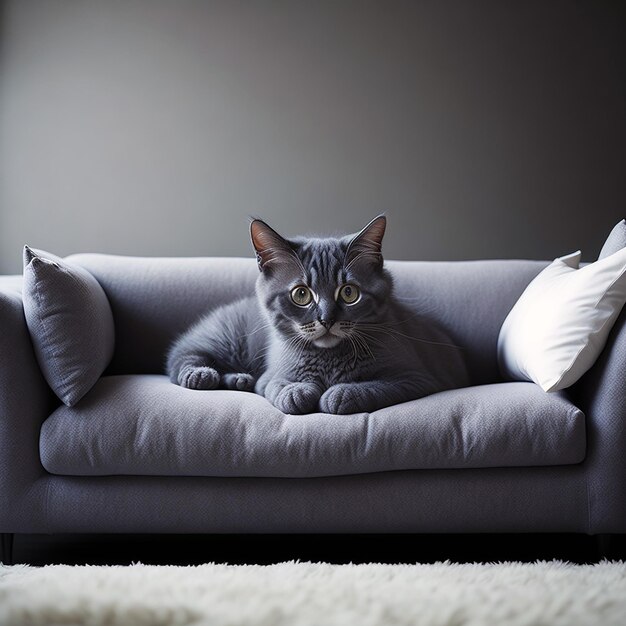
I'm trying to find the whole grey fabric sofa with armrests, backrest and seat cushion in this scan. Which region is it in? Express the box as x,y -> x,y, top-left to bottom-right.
0,254 -> 626,560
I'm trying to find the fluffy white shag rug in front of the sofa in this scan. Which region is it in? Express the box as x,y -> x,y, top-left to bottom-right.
0,561 -> 626,626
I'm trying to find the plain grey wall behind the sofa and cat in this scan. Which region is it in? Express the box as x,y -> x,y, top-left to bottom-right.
0,0 -> 626,272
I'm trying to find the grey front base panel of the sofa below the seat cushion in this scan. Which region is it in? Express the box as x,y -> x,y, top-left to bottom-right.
41,465 -> 594,541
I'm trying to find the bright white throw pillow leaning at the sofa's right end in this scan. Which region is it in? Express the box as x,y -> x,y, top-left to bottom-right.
498,248 -> 626,391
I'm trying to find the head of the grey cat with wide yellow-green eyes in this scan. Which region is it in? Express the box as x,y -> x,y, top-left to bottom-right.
250,215 -> 392,349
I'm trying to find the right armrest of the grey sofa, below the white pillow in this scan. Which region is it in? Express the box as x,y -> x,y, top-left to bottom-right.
570,307 -> 626,534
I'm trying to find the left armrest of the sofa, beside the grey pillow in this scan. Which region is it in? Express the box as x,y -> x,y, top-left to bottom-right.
0,276 -> 55,533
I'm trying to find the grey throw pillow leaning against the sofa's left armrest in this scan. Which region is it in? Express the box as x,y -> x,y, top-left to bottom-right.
22,246 -> 115,406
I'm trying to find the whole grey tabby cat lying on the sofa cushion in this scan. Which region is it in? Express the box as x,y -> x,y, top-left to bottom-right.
167,215 -> 469,414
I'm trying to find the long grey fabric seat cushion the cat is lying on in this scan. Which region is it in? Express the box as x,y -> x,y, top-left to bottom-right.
40,375 -> 585,477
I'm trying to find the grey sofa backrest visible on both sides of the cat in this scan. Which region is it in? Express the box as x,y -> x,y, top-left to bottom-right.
68,254 -> 547,384
